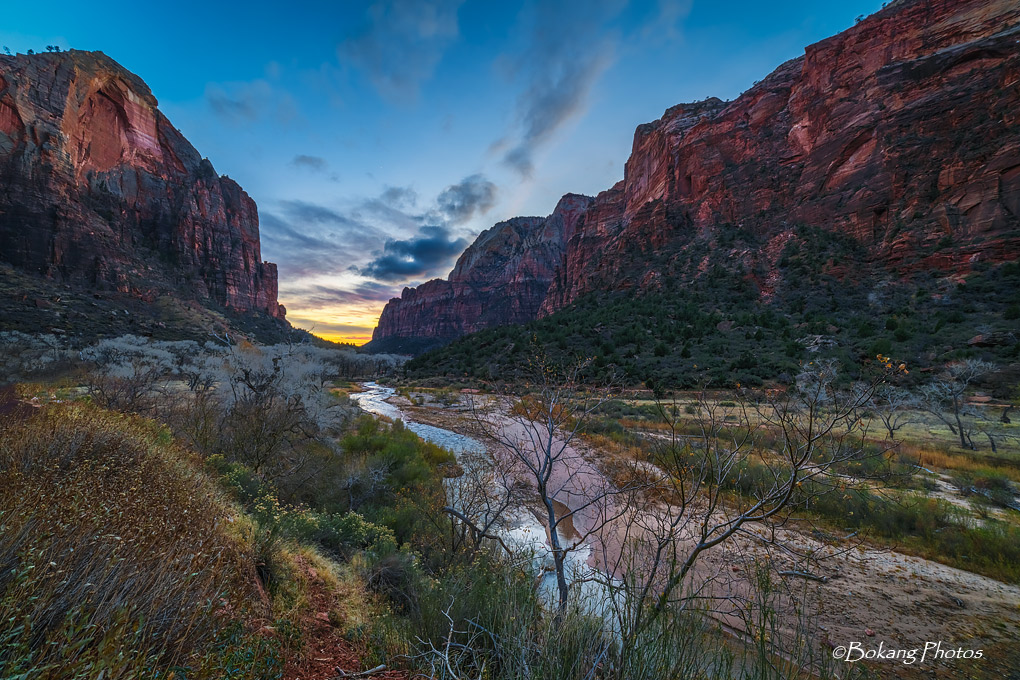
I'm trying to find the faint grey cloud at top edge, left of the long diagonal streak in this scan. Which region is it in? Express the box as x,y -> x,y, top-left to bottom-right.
338,0 -> 463,101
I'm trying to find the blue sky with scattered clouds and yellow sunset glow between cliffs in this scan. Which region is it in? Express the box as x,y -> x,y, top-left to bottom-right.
0,0 -> 881,344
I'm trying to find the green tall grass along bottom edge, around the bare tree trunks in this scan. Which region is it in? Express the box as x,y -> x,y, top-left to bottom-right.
371,553 -> 863,680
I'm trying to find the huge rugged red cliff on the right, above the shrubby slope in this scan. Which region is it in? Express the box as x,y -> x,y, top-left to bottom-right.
376,0 -> 1020,350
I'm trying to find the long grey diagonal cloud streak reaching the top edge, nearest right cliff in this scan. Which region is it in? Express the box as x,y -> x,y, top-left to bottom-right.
494,0 -> 622,176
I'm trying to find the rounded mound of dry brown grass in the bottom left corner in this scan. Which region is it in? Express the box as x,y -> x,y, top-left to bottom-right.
0,403 -> 275,678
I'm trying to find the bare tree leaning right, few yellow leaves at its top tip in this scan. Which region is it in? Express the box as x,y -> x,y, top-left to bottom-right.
603,362 -> 896,677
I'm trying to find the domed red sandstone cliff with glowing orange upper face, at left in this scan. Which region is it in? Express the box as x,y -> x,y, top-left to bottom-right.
0,51 -> 285,318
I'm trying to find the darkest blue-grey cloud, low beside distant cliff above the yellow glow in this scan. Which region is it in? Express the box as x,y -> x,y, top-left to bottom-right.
358,225 -> 467,281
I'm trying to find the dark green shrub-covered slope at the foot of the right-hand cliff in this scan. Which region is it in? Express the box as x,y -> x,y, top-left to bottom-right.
405,227 -> 1020,388
